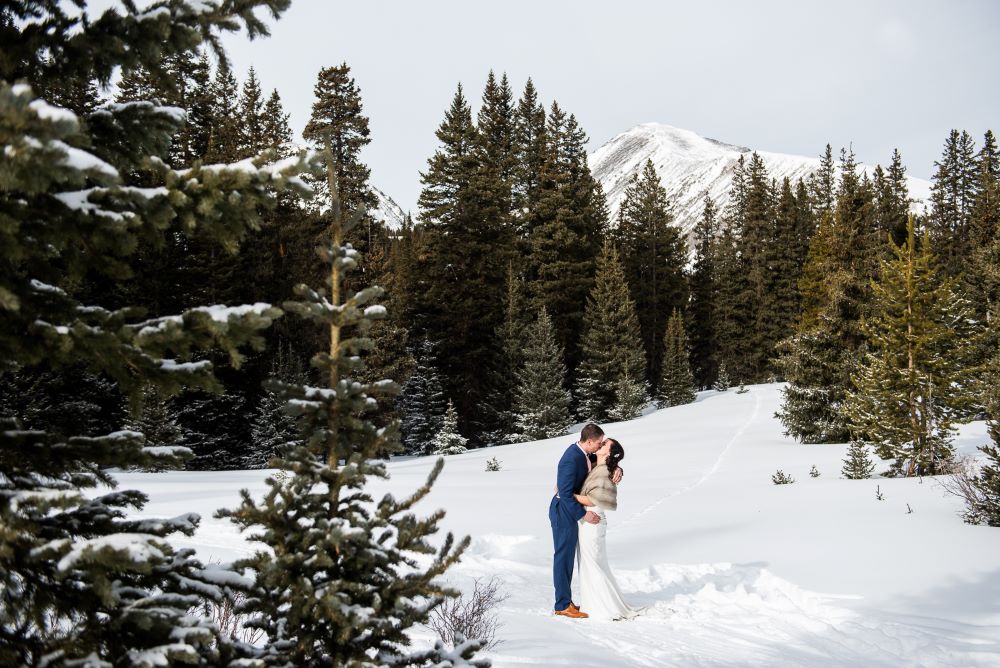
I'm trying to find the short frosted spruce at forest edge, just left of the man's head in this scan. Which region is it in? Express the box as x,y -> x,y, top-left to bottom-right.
513,307 -> 570,441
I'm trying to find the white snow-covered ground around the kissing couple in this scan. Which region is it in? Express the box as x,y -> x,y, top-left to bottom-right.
119,385 -> 1000,668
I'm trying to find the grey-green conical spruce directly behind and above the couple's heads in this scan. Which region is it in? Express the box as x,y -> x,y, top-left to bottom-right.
573,242 -> 646,422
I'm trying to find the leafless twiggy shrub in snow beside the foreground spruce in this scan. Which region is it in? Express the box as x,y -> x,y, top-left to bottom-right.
427,577 -> 509,650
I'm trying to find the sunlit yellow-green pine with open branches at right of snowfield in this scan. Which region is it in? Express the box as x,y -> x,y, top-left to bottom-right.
844,217 -> 977,476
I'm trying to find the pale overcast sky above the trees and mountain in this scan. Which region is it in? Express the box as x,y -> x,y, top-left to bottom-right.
226,0 -> 1000,212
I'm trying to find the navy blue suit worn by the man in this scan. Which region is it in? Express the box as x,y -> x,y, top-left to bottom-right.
549,443 -> 590,610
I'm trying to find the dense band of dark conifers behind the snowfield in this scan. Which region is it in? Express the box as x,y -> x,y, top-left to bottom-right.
7,52 -> 1000,482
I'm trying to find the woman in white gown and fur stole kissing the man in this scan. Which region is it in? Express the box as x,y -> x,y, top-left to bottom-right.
575,438 -> 638,619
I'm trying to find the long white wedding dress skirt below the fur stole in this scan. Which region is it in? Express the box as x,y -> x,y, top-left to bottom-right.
576,507 -> 639,619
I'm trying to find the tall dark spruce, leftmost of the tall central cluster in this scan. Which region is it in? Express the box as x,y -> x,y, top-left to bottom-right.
413,81 -> 509,445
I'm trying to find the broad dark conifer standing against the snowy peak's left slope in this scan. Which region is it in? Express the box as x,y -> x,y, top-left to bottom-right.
613,160 -> 687,382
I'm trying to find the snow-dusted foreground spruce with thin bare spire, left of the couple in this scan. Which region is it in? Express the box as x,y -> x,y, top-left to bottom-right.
219,142 -> 487,668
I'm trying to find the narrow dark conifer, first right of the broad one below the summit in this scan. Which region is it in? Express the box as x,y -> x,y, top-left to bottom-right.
688,194 -> 719,388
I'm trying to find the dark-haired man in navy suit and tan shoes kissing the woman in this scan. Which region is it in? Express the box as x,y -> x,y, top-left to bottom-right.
549,423 -> 617,619
